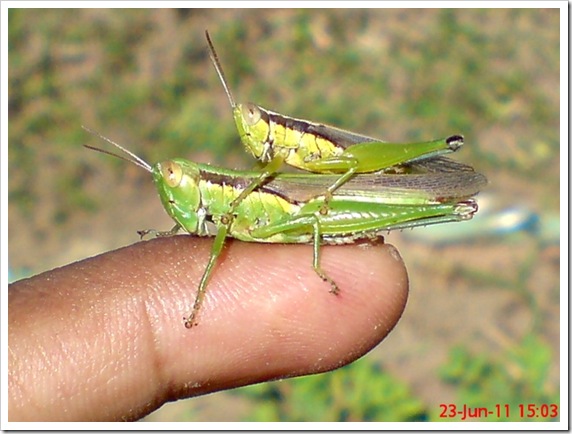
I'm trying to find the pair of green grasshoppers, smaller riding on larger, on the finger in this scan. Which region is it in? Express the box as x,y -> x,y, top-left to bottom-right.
87,33 -> 486,328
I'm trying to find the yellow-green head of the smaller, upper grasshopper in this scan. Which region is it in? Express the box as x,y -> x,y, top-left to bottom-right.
234,102 -> 270,162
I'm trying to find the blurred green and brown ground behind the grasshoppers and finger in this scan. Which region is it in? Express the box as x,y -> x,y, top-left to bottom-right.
9,9 -> 560,421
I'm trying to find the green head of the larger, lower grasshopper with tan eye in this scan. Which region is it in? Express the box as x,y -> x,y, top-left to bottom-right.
153,159 -> 201,233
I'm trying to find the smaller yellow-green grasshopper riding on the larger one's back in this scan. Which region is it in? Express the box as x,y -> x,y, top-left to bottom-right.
205,31 -> 463,208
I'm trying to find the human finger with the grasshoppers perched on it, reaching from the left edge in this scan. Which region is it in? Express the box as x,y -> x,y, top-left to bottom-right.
8,236 -> 408,422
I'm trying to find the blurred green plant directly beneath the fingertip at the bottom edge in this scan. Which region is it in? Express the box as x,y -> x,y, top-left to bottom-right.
235,358 -> 427,422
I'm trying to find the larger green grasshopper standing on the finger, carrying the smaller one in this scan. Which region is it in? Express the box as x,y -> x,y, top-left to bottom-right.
84,127 -> 486,328
